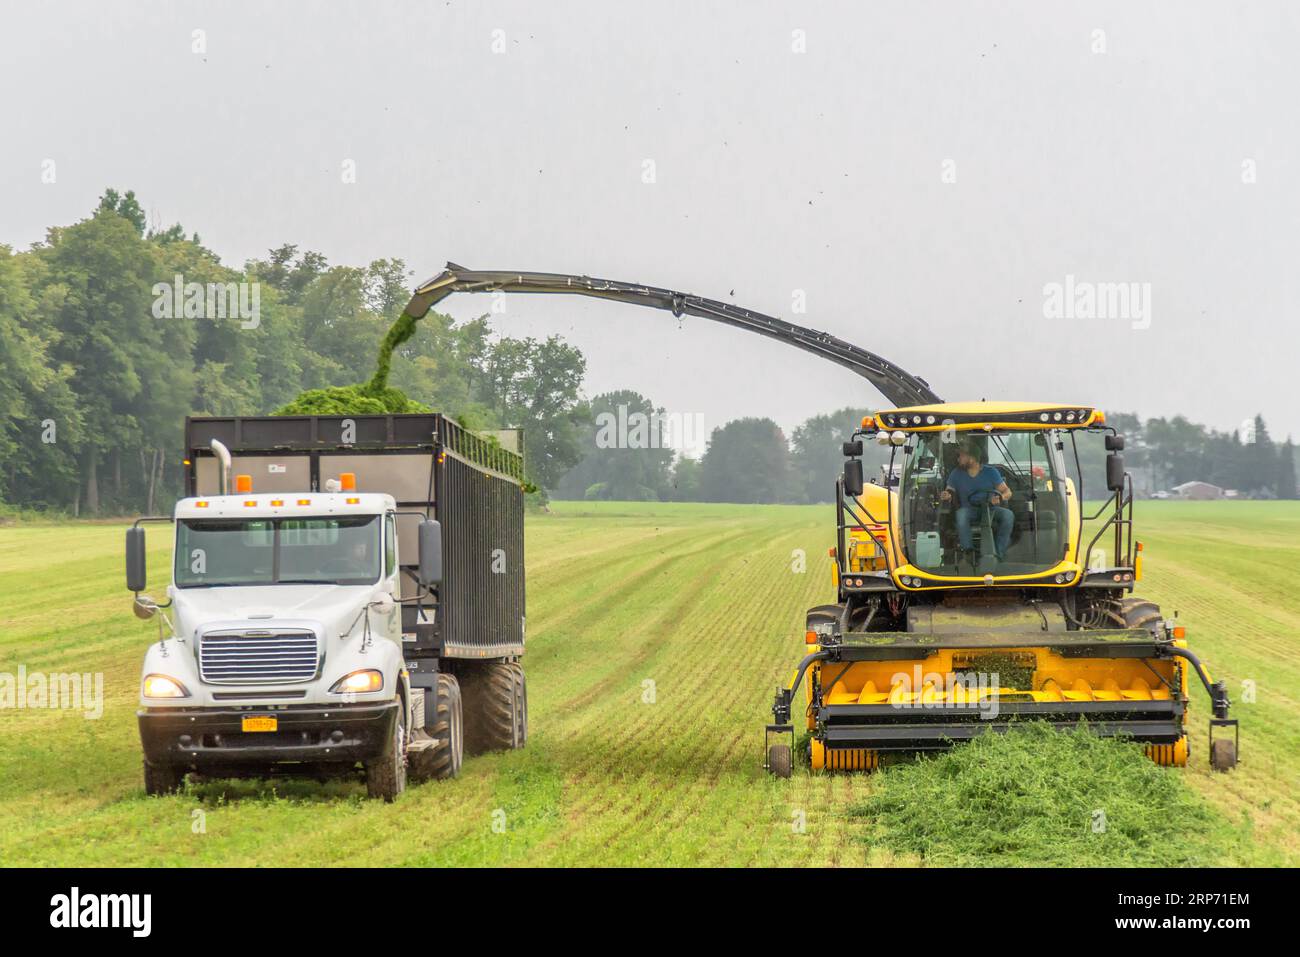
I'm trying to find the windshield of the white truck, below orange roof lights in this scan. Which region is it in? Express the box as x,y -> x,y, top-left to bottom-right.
176,515 -> 380,588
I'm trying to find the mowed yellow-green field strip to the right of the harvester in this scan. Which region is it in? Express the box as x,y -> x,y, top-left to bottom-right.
1118,502 -> 1300,866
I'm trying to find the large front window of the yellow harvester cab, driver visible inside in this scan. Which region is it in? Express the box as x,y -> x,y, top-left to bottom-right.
898,432 -> 1067,576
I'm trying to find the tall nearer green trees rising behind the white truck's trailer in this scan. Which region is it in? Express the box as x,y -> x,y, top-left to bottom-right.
0,190 -> 589,515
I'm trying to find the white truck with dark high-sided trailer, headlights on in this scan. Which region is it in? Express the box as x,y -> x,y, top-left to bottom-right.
126,413 -> 528,801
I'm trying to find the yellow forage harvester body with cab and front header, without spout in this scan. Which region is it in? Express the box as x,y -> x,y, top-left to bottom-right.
767,403 -> 1238,775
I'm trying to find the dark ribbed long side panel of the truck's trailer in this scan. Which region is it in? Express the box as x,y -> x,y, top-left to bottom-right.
438,452 -> 524,657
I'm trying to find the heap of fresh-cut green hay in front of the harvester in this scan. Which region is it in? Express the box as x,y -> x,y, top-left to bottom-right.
849,722 -> 1231,867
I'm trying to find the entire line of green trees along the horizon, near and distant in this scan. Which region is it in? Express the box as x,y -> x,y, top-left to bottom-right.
0,190 -> 1296,515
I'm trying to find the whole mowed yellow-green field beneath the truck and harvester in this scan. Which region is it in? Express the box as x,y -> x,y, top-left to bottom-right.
0,502 -> 1300,866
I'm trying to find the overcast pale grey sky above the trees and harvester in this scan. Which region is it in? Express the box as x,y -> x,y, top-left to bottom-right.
0,0 -> 1300,449
